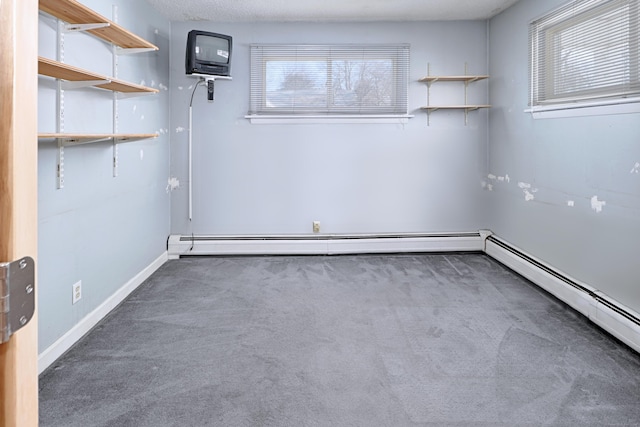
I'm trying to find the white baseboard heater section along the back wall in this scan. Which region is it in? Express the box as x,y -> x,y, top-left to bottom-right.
168,232 -> 484,259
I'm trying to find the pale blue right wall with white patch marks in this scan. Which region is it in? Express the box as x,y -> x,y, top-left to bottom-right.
487,0 -> 640,311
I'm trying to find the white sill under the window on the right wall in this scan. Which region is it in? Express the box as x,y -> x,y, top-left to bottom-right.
524,98 -> 640,119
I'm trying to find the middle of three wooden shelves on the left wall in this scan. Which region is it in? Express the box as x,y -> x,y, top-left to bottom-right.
38,57 -> 159,93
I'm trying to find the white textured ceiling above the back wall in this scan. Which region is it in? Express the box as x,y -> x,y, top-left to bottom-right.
147,0 -> 518,22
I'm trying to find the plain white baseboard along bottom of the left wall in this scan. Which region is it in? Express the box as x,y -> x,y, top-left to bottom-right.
38,252 -> 169,374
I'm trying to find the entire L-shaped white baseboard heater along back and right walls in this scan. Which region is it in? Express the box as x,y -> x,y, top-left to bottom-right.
168,230 -> 640,352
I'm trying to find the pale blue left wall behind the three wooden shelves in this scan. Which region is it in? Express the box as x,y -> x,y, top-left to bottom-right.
38,0 -> 171,351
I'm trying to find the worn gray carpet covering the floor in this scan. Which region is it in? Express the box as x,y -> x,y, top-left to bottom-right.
40,254 -> 640,427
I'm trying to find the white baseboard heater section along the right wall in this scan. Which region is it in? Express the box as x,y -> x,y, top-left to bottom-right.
484,235 -> 640,352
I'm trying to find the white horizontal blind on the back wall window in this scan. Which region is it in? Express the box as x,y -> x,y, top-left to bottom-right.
249,44 -> 409,116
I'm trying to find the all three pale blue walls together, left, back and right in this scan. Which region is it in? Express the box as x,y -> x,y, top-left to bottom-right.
33,0 -> 640,358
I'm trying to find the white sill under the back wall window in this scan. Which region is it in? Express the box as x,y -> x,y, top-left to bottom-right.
244,114 -> 413,125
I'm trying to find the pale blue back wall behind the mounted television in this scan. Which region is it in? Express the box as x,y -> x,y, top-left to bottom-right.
170,22 -> 488,234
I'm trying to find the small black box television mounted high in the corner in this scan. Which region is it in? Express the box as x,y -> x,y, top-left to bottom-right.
185,30 -> 233,76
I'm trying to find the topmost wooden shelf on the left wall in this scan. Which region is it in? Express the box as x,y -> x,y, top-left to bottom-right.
39,0 -> 158,50
